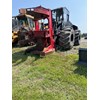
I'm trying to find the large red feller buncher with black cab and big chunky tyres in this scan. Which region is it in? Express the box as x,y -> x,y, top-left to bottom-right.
12,6 -> 80,55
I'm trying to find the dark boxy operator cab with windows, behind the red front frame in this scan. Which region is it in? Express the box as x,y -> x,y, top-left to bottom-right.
52,7 -> 69,29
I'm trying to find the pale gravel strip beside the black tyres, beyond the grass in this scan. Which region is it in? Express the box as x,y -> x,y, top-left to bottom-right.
59,38 -> 87,55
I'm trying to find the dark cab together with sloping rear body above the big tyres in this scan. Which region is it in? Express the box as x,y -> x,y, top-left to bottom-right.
52,7 -> 78,34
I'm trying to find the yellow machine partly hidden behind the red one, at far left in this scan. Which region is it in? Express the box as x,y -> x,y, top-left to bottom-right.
12,14 -> 34,46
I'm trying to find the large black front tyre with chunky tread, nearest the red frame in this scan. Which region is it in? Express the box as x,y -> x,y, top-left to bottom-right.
59,30 -> 74,50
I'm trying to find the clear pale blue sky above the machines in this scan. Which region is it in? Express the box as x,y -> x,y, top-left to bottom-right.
12,0 -> 87,33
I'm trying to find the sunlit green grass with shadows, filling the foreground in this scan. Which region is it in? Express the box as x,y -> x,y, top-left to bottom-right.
12,48 -> 87,100
